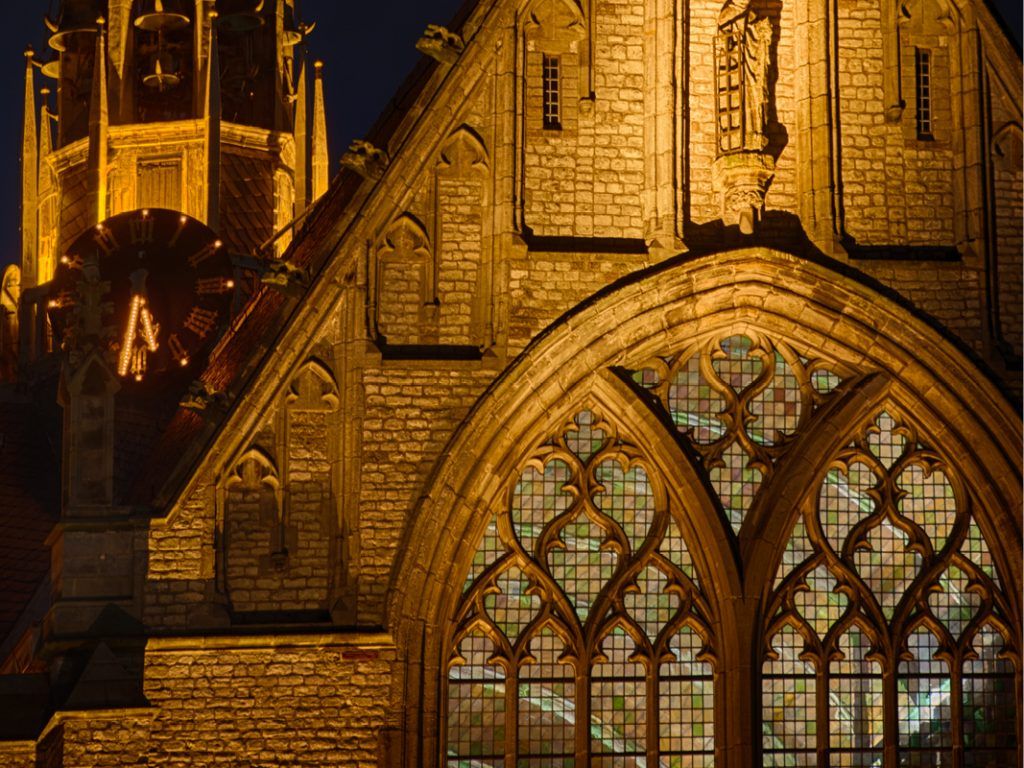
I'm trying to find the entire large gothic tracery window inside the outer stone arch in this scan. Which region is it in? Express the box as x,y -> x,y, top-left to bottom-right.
444,329 -> 1020,768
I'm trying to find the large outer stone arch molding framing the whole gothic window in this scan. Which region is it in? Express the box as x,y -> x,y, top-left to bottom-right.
389,249 -> 1022,766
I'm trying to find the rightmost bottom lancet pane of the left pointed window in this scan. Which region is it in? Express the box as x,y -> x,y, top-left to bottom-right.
658,629 -> 715,766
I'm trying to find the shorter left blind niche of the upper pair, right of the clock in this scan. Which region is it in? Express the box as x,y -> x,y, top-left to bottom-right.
372,213 -> 438,346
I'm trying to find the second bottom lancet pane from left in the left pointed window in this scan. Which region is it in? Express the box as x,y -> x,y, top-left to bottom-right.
518,629 -> 575,758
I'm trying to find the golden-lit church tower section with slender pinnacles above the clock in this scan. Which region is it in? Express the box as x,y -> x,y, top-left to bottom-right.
19,0 -> 328,319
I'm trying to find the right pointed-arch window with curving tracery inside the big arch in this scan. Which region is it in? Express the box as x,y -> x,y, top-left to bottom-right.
762,409 -> 1017,766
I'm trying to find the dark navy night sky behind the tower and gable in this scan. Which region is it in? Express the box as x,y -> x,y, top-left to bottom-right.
0,0 -> 1022,270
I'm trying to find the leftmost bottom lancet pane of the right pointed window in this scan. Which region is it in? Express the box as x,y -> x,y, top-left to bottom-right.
761,627 -> 817,765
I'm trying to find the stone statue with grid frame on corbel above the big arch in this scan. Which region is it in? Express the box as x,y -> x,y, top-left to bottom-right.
712,0 -> 775,234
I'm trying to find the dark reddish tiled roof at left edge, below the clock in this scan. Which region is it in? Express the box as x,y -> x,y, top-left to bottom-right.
0,399 -> 60,645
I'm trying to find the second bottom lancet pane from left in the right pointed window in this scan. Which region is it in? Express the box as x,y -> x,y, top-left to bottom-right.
828,627 -> 884,768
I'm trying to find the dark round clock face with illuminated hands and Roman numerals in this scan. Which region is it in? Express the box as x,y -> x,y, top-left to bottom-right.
49,209 -> 234,382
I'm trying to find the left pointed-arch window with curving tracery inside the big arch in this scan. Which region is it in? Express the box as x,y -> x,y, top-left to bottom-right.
446,411 -> 714,768
